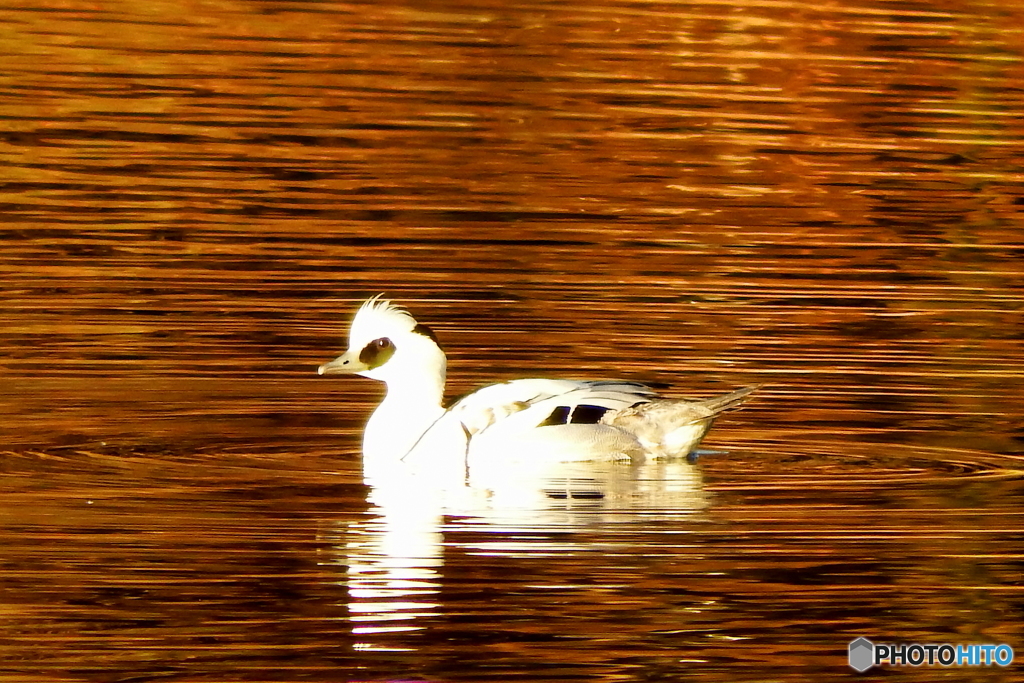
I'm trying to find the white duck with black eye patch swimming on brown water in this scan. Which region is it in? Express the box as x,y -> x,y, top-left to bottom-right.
319,296 -> 757,462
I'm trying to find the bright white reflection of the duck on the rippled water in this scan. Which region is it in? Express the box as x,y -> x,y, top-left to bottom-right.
336,450 -> 708,650
